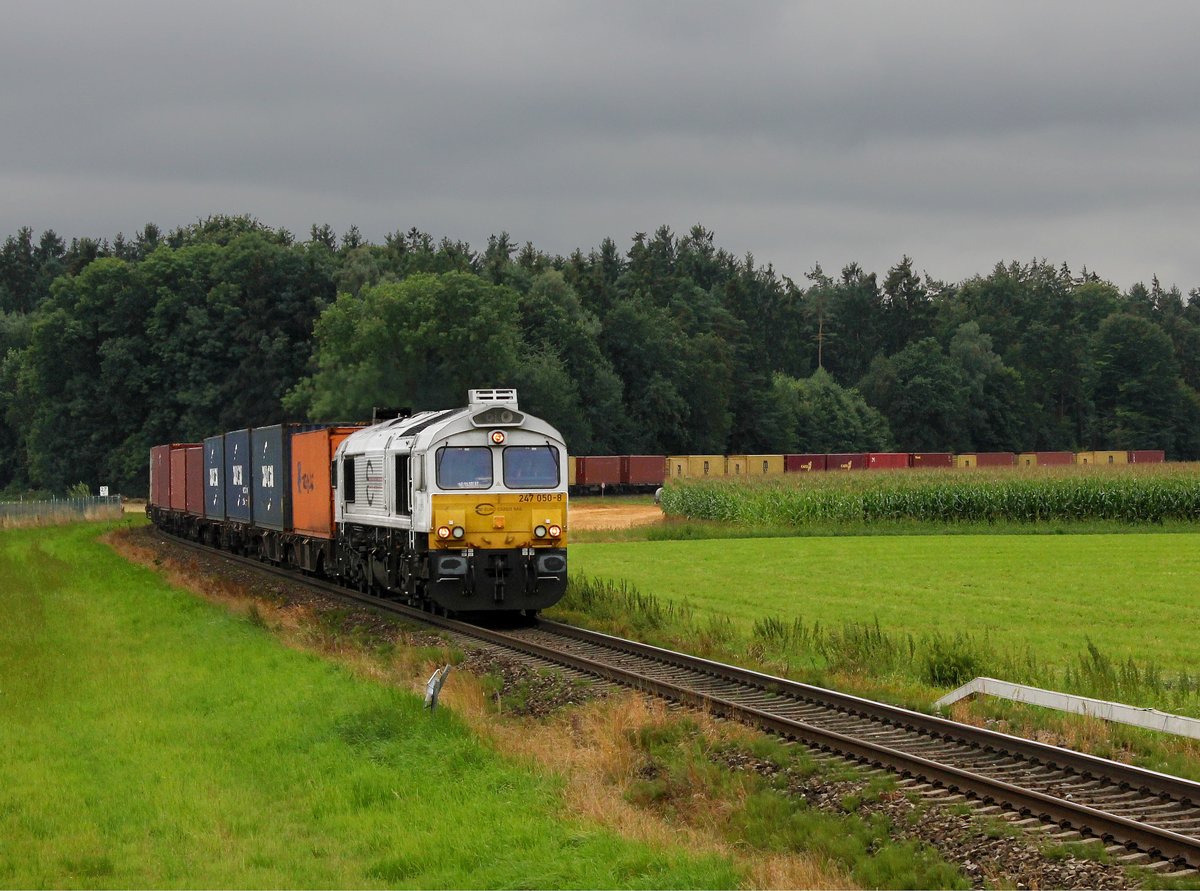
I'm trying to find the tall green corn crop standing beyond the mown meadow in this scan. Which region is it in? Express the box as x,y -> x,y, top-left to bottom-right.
662,464 -> 1200,527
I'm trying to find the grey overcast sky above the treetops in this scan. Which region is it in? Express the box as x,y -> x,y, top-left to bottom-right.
0,0 -> 1200,292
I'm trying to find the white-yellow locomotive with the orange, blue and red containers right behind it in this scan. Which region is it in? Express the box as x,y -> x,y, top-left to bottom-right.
146,389 -> 568,615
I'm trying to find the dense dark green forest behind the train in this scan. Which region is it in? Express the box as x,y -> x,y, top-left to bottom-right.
0,217 -> 1200,495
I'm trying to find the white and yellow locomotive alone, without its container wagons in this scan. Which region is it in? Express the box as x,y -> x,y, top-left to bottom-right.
331,389 -> 568,612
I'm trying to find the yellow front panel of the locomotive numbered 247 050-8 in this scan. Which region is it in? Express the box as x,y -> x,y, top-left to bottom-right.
430,492 -> 566,549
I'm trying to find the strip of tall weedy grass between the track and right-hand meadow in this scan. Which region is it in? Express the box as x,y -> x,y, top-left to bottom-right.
548,574 -> 1200,779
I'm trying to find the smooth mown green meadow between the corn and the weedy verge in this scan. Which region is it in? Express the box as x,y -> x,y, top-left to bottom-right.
571,533 -> 1200,672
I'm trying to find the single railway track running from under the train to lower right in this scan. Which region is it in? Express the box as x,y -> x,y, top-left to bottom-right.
162,539 -> 1200,877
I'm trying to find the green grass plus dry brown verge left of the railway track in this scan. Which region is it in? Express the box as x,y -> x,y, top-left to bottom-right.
0,527 -> 998,887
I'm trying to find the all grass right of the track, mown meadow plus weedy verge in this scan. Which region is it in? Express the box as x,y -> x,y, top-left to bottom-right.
550,527 -> 1200,779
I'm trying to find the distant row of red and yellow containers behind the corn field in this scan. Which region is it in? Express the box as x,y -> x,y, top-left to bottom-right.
568,449 -> 1165,494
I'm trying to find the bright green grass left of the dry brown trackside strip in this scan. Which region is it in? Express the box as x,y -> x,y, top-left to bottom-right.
0,526 -> 740,887
